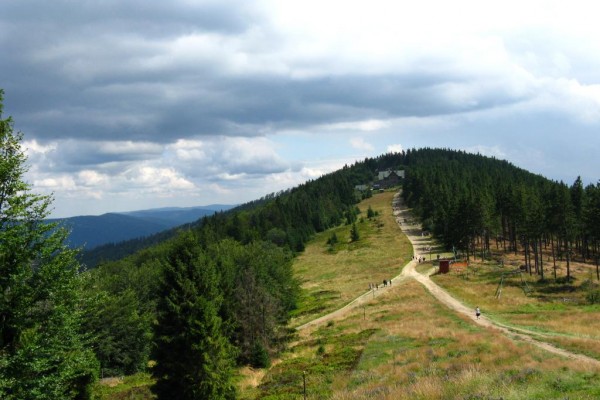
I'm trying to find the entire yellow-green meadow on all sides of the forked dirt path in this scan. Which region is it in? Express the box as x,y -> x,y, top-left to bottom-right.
98,192 -> 600,400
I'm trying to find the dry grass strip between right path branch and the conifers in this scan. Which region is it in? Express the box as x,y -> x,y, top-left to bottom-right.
433,255 -> 600,358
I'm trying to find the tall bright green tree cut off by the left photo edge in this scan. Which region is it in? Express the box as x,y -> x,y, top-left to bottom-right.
0,90 -> 98,399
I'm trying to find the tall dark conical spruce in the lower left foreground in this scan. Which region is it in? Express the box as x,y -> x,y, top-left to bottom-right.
152,232 -> 235,400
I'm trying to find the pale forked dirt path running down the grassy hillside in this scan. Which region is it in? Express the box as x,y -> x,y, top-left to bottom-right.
296,193 -> 600,367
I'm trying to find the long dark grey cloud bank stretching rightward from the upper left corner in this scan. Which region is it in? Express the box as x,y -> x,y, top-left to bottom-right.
0,1 -> 528,143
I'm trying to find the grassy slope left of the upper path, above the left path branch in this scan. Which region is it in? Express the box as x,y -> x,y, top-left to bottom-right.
292,192 -> 412,326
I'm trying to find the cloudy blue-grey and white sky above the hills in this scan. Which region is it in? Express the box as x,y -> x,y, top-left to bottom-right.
0,0 -> 600,217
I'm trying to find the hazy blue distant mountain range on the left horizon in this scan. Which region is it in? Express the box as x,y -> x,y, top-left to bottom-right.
50,204 -> 234,250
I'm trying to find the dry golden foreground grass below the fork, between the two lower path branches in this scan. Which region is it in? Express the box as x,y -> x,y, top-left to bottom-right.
257,281 -> 600,399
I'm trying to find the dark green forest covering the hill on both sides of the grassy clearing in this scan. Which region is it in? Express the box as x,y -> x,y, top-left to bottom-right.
85,149 -> 600,391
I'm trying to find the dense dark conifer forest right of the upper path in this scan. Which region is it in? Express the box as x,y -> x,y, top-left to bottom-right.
403,149 -> 600,281
